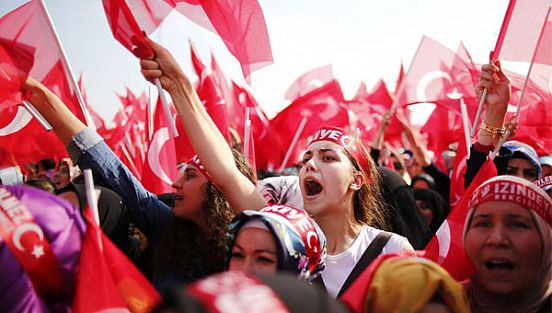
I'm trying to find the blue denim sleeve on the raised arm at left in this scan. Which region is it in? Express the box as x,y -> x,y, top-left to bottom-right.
67,128 -> 171,241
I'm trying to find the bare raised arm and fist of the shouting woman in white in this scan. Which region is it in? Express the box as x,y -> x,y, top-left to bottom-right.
140,39 -> 266,213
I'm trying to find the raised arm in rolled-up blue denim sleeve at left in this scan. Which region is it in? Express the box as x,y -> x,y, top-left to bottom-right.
25,79 -> 170,238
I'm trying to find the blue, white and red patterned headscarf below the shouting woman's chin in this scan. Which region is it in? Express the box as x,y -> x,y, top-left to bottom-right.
228,205 -> 326,281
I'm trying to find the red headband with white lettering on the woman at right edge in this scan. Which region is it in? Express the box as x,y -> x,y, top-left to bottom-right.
468,176 -> 552,226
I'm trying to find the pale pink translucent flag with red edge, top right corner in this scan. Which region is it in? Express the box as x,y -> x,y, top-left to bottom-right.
491,0 -> 552,65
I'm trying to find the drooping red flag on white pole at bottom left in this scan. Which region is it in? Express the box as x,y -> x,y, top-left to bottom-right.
73,208 -> 160,313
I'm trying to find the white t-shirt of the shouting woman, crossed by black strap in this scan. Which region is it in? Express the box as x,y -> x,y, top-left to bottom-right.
322,225 -> 412,298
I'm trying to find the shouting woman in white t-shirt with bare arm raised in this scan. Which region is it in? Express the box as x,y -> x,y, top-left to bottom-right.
135,39 -> 412,297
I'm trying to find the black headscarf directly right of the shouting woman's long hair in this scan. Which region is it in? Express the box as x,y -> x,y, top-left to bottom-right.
378,167 -> 431,249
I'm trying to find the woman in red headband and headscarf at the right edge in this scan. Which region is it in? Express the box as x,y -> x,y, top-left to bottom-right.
464,176 -> 552,313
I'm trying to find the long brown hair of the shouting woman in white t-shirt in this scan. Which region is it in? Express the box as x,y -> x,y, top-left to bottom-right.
345,139 -> 392,231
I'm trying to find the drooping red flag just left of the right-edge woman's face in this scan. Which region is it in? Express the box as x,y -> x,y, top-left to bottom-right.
424,159 -> 497,281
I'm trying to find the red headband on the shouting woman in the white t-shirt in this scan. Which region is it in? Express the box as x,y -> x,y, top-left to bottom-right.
309,126 -> 371,179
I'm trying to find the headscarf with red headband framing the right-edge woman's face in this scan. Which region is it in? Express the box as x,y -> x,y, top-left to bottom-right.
463,175 -> 552,313
